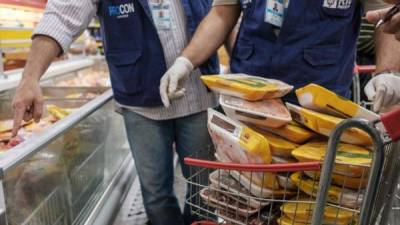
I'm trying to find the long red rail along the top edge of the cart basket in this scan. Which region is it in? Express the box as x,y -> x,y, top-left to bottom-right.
185,158 -> 321,172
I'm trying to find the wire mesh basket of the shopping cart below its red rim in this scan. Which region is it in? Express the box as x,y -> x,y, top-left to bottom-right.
185,148 -> 370,225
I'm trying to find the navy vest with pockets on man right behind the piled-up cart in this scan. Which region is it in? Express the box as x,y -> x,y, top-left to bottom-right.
231,0 -> 362,102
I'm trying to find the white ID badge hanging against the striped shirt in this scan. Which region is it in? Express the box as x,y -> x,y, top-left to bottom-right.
149,0 -> 171,30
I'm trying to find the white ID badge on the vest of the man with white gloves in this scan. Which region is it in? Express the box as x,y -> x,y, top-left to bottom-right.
264,0 -> 285,27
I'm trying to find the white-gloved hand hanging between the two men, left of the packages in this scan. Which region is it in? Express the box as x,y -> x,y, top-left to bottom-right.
160,56 -> 194,107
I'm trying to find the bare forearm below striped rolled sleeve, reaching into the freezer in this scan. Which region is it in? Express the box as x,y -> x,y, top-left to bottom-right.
23,35 -> 62,81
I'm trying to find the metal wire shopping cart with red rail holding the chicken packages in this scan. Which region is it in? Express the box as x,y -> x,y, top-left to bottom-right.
185,106 -> 400,225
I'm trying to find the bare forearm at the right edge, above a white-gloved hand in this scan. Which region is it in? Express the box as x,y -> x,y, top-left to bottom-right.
375,29 -> 400,73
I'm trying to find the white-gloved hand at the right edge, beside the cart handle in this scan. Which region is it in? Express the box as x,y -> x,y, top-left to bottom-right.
364,73 -> 400,112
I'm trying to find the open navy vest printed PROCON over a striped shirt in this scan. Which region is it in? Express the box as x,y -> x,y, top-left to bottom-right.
98,0 -> 219,107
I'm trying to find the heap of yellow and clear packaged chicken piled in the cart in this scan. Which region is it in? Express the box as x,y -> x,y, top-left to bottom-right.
201,74 -> 378,224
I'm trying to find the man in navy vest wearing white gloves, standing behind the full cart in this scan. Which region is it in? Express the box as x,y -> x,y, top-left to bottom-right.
161,0 -> 400,111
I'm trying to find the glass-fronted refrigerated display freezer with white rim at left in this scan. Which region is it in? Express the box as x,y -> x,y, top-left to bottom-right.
0,59 -> 134,225
